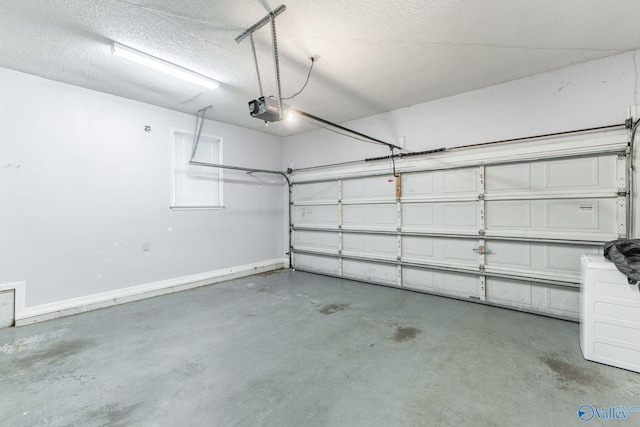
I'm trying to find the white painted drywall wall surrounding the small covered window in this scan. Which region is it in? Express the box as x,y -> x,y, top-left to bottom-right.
0,69 -> 286,308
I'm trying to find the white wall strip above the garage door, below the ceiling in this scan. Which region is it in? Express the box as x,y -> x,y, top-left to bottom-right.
284,51 -> 640,168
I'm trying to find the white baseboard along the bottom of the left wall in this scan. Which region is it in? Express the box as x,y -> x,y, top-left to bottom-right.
13,258 -> 289,326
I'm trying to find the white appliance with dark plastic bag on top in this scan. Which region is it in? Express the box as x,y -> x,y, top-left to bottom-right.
580,255 -> 640,372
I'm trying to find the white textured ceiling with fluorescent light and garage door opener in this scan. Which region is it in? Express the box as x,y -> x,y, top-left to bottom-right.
0,0 -> 640,135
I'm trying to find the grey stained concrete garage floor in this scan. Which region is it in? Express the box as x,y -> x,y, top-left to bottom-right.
0,270 -> 640,427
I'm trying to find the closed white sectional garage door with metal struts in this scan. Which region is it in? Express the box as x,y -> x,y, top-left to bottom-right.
291,132 -> 628,320
